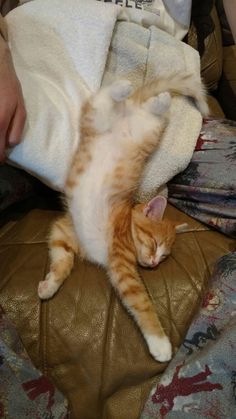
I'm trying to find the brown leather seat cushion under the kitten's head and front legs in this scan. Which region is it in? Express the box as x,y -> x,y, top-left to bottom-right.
0,206 -> 234,419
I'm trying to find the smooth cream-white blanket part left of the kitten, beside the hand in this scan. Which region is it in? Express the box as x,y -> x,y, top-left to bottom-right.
7,0 -> 120,190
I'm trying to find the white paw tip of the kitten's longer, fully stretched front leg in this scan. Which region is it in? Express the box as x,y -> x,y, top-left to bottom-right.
146,335 -> 172,362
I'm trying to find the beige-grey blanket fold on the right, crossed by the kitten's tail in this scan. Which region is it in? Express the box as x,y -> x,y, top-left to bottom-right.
103,22 -> 202,201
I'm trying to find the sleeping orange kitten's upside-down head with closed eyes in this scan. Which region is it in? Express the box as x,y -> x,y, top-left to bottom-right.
132,196 -> 187,268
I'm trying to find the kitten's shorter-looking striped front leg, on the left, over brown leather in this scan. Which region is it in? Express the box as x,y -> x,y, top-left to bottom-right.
38,214 -> 79,300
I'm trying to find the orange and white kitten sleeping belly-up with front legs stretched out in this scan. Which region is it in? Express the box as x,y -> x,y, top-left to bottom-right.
38,75 -> 207,362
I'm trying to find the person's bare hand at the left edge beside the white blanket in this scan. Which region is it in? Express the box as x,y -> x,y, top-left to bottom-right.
0,39 -> 26,162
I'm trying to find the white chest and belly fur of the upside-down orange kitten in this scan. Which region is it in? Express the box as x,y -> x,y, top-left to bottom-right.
70,136 -> 119,265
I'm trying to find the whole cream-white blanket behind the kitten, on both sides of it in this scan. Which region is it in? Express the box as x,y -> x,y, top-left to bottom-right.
7,0 -> 201,199
